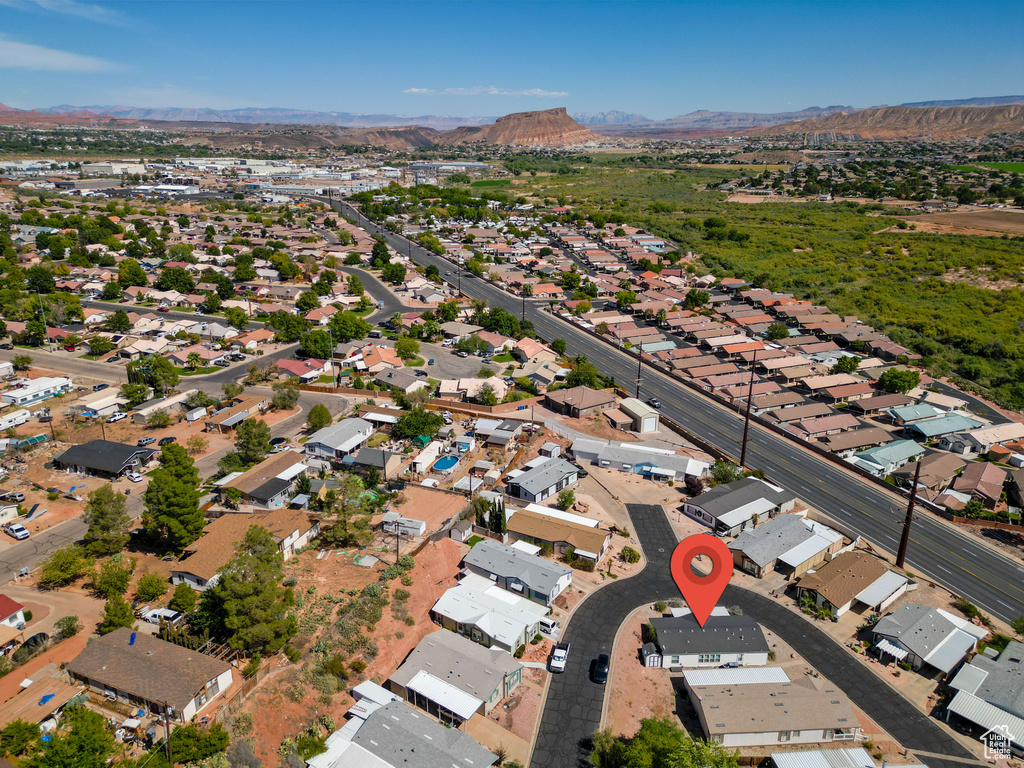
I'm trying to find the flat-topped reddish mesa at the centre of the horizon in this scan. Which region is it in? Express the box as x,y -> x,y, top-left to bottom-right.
437,106 -> 602,146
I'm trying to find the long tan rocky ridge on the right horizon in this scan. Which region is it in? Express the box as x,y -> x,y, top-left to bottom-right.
752,104 -> 1024,138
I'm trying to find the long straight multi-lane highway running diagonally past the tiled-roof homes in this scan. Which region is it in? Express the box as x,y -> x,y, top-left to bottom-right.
336,204 -> 1024,621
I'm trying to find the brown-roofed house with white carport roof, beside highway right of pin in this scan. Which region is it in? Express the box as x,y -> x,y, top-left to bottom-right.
797,552 -> 910,616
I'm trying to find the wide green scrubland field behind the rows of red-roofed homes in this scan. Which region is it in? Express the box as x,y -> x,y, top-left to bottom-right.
517,157 -> 1024,408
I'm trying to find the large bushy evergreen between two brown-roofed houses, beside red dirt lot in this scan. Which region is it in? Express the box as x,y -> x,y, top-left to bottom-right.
196,525 -> 297,655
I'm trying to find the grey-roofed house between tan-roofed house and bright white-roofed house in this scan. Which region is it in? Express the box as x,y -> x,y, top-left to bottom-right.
462,539 -> 572,605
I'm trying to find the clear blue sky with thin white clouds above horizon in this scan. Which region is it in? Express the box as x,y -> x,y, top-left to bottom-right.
0,0 -> 1024,119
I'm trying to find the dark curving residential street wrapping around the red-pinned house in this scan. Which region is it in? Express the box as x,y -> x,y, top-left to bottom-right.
530,504 -> 972,768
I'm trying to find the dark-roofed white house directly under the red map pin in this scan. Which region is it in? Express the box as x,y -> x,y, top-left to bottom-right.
641,608 -> 770,668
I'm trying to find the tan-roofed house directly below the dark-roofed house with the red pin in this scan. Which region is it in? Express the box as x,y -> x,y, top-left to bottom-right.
690,677 -> 860,749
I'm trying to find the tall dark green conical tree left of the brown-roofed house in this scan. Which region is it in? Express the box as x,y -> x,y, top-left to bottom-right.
142,442 -> 206,551
